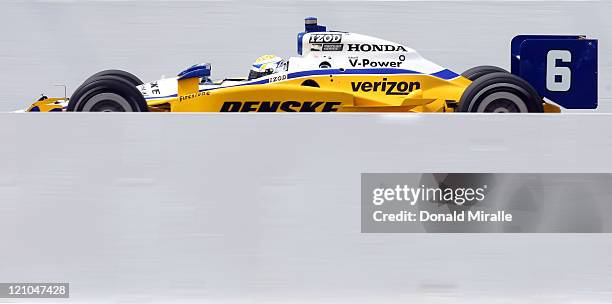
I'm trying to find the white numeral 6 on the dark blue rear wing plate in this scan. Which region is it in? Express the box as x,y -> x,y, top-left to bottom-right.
546,50 -> 572,92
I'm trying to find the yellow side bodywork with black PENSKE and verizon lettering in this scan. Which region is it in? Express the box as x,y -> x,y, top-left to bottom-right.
148,75 -> 471,112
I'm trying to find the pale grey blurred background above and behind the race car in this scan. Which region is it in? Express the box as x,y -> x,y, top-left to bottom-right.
0,0 -> 612,112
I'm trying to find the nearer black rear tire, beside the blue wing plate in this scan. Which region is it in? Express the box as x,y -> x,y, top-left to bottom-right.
459,72 -> 544,113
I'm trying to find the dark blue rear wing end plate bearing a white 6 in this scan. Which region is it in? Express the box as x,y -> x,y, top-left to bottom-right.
510,35 -> 597,109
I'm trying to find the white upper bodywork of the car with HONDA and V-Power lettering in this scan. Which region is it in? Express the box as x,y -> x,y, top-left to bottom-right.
138,32 -> 445,99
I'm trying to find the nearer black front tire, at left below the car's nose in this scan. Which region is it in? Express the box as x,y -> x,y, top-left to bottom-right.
67,76 -> 149,112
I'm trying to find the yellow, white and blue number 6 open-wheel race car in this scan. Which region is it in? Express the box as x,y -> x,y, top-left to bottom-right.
27,17 -> 597,113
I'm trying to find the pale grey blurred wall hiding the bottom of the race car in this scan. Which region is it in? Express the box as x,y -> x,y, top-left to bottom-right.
0,113 -> 612,303
